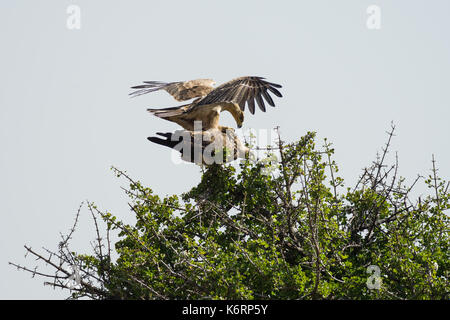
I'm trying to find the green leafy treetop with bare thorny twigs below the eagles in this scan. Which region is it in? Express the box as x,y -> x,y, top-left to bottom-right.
9,127 -> 450,299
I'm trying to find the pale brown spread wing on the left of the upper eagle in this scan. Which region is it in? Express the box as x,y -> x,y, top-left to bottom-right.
130,79 -> 214,101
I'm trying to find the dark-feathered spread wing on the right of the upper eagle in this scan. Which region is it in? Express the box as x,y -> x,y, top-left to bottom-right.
193,76 -> 282,114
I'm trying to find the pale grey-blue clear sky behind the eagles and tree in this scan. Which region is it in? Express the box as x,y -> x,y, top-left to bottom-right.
0,0 -> 450,299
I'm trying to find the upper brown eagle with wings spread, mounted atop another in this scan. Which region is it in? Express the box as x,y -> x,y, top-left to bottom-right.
130,76 -> 282,131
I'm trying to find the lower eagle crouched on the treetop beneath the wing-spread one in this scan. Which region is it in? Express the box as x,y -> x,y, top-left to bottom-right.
147,128 -> 250,165
